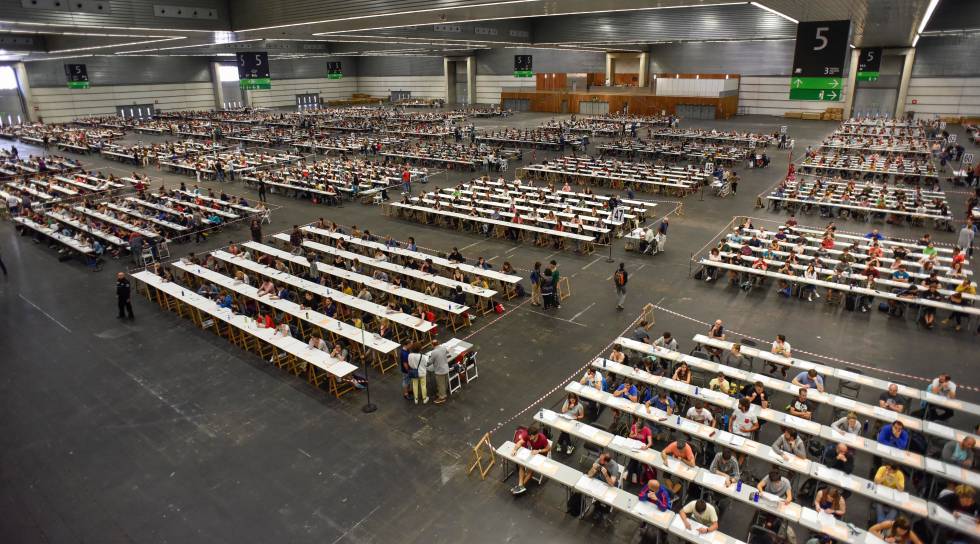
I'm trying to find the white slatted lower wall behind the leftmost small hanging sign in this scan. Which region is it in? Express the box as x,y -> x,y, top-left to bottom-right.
28,82 -> 214,123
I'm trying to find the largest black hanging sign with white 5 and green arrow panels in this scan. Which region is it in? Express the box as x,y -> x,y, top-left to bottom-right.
789,21 -> 851,101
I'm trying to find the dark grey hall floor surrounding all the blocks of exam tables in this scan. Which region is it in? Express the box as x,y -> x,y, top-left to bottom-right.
0,114 -> 980,544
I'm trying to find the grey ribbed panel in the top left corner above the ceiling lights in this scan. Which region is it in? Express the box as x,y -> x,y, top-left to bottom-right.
0,0 -> 233,30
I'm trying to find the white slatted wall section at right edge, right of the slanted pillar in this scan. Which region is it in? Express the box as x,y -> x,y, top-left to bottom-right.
905,77 -> 980,117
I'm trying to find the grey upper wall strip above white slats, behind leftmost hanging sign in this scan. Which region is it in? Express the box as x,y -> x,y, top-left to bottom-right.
27,56 -> 211,87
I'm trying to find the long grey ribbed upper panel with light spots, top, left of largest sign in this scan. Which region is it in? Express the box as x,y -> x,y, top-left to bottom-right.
532,4 -> 796,43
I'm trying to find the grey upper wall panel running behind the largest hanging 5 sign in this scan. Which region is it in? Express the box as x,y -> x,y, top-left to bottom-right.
650,40 -> 851,76
